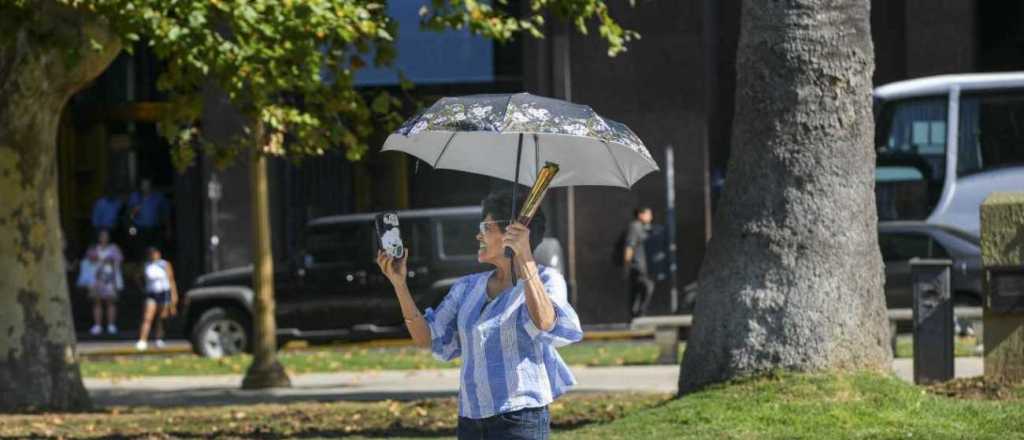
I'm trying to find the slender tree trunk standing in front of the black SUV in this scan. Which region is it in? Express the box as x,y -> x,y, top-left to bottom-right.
242,141 -> 292,390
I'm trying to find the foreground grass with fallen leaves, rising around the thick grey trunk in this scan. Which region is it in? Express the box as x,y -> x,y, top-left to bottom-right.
9,373 -> 1024,440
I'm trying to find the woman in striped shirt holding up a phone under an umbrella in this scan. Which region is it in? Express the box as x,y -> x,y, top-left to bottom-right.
377,192 -> 583,439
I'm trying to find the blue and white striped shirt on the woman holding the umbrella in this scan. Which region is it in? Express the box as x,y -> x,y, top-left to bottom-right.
424,267 -> 583,419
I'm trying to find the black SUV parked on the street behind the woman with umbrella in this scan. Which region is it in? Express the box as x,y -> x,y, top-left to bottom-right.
183,207 -> 563,357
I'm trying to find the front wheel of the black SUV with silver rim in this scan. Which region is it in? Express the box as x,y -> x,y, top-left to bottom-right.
191,307 -> 252,358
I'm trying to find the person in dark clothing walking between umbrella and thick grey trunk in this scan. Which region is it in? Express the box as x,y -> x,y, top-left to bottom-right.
623,207 -> 654,317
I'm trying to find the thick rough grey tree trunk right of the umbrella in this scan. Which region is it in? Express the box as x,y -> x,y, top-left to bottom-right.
679,0 -> 892,393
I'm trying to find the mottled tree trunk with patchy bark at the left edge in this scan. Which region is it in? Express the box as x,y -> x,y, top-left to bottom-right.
0,1 -> 121,411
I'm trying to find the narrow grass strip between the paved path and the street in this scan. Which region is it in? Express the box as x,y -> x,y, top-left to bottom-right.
81,341 -> 671,378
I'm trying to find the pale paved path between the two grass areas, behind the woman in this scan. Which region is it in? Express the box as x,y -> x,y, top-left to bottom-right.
85,357 -> 982,406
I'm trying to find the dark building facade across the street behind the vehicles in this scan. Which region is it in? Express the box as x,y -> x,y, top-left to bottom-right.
59,0 -> 1024,324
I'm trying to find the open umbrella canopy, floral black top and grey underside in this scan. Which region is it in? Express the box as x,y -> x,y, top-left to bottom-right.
382,93 -> 658,188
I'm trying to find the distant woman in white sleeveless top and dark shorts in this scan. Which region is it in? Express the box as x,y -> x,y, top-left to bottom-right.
135,248 -> 178,351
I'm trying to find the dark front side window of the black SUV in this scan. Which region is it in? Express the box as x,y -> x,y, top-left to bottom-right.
306,223 -> 374,264
